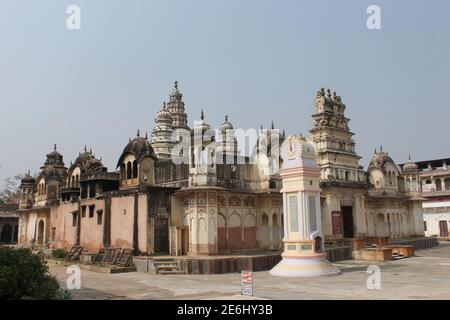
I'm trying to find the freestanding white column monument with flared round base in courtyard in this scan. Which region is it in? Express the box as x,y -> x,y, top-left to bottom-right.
270,136 -> 340,277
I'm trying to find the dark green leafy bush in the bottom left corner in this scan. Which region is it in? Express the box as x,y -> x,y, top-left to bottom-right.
0,247 -> 70,300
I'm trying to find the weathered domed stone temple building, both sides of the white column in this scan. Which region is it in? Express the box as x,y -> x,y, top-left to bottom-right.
18,82 -> 423,256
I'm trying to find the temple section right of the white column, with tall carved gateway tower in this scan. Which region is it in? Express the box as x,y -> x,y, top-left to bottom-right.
310,88 -> 424,241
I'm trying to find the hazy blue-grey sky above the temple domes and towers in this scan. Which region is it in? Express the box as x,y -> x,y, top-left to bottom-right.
0,0 -> 450,180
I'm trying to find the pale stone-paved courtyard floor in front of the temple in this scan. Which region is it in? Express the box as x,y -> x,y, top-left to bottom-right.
50,242 -> 450,300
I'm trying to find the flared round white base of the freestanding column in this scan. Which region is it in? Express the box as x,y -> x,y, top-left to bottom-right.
269,253 -> 341,278
